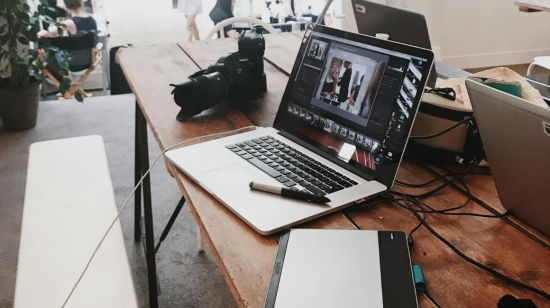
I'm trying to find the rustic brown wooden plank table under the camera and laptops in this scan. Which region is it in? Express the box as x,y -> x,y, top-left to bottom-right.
117,33 -> 550,308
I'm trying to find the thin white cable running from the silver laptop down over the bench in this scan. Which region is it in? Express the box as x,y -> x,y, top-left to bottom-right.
61,126 -> 257,308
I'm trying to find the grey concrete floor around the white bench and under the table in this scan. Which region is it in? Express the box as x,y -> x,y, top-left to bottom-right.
0,95 -> 236,308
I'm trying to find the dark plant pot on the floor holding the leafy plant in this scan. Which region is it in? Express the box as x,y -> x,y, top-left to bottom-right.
0,82 -> 40,131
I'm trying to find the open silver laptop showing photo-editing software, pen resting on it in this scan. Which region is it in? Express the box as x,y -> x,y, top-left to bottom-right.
166,25 -> 433,235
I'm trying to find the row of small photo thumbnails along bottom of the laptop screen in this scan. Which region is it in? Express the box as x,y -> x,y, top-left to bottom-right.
288,104 -> 380,153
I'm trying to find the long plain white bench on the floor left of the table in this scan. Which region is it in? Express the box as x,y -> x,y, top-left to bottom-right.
14,136 -> 138,308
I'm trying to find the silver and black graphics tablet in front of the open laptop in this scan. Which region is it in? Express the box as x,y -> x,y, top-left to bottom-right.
264,229 -> 418,308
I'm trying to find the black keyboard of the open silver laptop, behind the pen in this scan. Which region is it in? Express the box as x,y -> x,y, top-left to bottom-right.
227,136 -> 358,195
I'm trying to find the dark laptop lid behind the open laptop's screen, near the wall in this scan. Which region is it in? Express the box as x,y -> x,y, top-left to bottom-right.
351,0 -> 437,88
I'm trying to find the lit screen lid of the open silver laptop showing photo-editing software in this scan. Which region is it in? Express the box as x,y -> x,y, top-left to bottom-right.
273,25 -> 433,188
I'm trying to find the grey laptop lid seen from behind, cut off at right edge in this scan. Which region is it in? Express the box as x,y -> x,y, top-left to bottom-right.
466,80 -> 550,235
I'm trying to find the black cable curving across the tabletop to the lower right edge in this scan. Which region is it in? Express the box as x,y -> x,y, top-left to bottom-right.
403,195 -> 550,300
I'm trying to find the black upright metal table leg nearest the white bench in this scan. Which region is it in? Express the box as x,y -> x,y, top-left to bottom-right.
136,102 -> 158,308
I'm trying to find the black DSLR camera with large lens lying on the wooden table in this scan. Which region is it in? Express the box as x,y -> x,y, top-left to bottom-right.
171,23 -> 267,121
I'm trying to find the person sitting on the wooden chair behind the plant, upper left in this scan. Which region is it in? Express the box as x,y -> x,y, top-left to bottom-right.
38,0 -> 97,72
